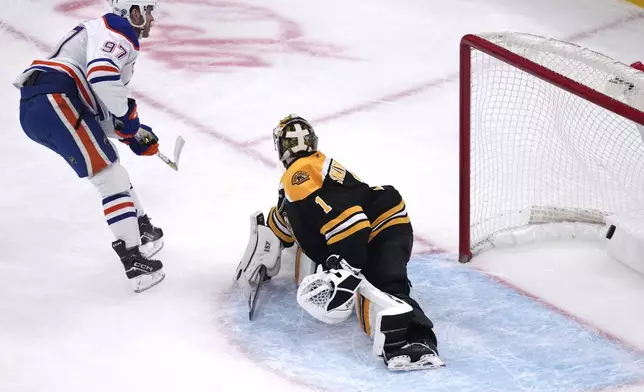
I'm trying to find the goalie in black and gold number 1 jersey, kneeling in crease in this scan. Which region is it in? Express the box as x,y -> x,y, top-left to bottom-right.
237,115 -> 443,370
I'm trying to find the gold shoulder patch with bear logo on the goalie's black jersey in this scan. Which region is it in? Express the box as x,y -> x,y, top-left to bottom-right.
281,151 -> 326,202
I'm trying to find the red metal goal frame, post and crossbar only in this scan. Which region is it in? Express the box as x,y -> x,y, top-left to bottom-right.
458,34 -> 644,263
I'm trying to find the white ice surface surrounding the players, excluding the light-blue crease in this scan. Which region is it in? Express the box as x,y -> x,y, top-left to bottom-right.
0,0 -> 644,392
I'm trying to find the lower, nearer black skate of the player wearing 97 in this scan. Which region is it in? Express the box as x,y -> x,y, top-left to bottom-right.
112,240 -> 165,293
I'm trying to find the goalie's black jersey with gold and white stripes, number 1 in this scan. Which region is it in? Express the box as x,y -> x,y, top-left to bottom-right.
268,151 -> 413,268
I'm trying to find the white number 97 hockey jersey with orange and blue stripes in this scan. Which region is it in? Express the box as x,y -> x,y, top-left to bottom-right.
14,14 -> 139,129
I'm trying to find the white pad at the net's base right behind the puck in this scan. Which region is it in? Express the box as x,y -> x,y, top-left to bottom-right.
606,211 -> 644,275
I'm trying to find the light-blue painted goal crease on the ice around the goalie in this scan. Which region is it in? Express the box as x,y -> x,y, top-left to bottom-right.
222,255 -> 644,392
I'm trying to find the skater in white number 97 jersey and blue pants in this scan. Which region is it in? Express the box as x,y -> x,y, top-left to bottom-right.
14,0 -> 165,292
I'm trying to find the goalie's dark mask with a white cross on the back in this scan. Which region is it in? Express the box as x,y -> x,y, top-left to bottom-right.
273,114 -> 318,167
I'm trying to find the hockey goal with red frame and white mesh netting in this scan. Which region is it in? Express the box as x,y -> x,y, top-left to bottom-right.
459,33 -> 644,262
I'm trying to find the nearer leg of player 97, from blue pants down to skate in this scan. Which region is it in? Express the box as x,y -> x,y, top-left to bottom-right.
20,94 -> 163,291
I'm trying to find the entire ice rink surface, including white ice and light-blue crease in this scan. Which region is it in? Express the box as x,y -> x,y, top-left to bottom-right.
0,0 -> 644,392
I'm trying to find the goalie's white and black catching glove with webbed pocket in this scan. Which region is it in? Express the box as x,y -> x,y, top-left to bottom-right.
297,255 -> 363,324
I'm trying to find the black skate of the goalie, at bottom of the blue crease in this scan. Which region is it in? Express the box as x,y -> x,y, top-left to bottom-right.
383,339 -> 445,371
